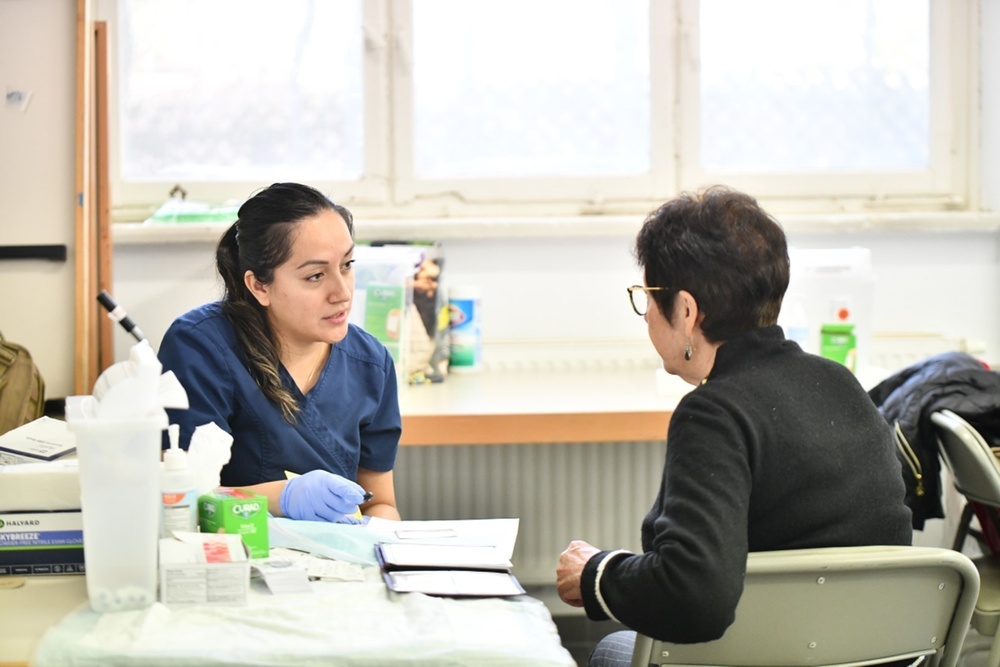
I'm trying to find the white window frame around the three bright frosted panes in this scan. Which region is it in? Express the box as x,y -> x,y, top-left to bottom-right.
92,0 -> 979,224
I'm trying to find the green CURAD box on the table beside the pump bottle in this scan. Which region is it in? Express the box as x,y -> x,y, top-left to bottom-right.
198,486 -> 271,558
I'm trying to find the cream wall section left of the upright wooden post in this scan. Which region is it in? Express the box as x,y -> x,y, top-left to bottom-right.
0,0 -> 76,396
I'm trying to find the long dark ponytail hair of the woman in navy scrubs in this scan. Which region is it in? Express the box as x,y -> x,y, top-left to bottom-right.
215,183 -> 354,423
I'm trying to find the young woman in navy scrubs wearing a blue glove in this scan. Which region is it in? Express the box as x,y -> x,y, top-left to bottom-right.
159,183 -> 401,523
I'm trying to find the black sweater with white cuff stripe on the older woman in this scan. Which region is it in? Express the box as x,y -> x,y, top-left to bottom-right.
581,326 -> 912,643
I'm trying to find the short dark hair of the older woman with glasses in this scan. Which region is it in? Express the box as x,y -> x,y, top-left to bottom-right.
635,185 -> 788,342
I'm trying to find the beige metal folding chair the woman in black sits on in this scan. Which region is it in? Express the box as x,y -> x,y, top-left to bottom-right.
632,546 -> 979,667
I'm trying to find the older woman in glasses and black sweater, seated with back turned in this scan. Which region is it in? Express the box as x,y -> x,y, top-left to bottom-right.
557,187 -> 912,666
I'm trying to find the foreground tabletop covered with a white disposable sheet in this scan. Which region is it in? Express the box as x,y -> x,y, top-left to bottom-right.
0,524 -> 575,667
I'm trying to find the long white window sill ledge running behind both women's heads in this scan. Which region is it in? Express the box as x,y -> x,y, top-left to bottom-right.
112,212 -> 1000,245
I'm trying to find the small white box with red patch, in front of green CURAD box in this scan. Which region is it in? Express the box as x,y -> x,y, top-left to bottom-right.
160,531 -> 250,606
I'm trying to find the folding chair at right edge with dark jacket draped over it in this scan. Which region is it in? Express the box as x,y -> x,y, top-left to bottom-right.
931,410 -> 1000,667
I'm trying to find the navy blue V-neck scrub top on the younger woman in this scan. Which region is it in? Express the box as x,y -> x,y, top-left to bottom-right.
159,303 -> 402,486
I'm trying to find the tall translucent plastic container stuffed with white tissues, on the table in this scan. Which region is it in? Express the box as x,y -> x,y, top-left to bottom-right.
66,341 -> 187,612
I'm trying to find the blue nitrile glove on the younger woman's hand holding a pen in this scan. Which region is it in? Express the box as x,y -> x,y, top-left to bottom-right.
279,470 -> 365,523
